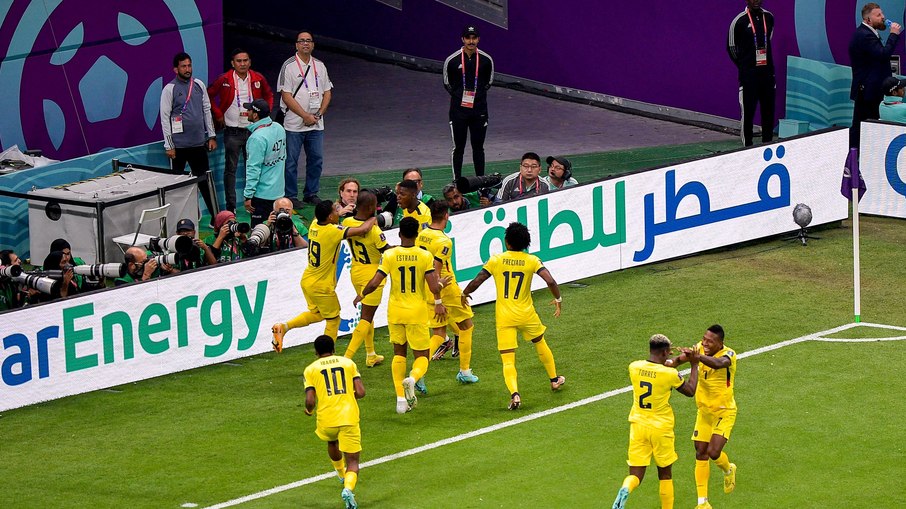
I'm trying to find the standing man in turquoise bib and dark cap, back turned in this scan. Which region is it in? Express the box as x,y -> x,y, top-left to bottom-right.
242,99 -> 286,226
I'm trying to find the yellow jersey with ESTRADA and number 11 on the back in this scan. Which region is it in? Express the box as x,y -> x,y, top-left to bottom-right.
378,246 -> 434,325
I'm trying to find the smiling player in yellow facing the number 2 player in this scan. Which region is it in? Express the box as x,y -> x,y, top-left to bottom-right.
670,324 -> 736,509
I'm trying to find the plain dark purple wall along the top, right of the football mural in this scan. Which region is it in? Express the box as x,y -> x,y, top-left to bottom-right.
224,0 -> 903,123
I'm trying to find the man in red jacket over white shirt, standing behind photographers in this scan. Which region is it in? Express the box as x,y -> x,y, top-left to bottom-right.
208,49 -> 274,212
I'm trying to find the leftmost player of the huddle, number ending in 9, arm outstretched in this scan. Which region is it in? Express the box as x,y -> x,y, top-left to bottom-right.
271,200 -> 376,353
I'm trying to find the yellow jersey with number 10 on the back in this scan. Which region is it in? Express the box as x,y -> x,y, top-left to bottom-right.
305,355 -> 361,428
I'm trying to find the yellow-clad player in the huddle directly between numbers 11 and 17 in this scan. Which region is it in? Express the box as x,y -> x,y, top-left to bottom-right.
415,200 -> 478,384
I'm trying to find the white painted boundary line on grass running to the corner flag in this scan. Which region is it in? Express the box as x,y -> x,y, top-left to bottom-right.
205,323 -> 906,509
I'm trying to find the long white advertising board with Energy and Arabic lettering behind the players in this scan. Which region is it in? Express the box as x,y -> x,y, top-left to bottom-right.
0,129 -> 849,410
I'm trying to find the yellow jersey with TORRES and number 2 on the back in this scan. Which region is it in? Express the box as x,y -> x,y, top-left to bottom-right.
629,361 -> 683,430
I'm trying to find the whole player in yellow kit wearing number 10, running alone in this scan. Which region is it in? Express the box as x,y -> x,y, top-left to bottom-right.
304,336 -> 365,509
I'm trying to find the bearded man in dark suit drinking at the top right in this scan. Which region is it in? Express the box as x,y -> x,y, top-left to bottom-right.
849,2 -> 903,148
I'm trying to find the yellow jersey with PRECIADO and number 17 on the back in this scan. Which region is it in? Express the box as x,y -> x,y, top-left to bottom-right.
484,251 -> 544,327
